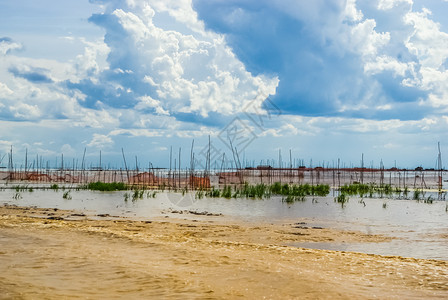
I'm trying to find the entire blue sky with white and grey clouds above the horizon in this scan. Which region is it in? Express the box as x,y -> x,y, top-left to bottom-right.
0,0 -> 448,169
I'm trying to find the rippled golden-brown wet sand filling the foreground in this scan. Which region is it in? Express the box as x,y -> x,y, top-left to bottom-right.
0,206 -> 448,299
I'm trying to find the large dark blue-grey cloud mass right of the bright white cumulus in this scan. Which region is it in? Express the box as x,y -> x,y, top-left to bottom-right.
193,0 -> 428,120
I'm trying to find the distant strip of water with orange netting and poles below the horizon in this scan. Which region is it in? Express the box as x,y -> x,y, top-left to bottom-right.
0,166 -> 448,192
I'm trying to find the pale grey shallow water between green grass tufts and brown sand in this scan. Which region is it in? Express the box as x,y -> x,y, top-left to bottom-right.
0,190 -> 448,260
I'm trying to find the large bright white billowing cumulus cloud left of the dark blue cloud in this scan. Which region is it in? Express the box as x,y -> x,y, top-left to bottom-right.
85,0 -> 278,117
